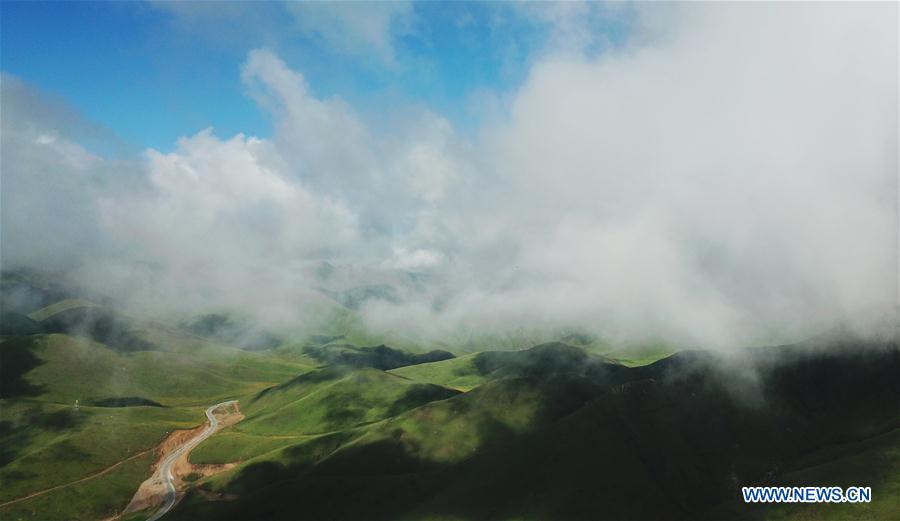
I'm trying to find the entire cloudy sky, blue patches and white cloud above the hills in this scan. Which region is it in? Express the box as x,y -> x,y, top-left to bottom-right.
0,2 -> 900,347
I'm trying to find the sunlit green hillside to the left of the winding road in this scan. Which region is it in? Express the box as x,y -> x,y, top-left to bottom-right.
0,324 -> 320,519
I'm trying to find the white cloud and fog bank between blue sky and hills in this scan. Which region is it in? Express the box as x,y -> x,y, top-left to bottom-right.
0,3 -> 900,348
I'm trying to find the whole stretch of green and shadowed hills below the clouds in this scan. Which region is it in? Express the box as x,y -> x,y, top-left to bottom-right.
0,272 -> 900,520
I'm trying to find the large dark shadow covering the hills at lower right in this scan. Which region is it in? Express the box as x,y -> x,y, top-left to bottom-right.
172,340 -> 900,520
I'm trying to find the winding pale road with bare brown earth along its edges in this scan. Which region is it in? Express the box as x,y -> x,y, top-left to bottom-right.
123,400 -> 243,521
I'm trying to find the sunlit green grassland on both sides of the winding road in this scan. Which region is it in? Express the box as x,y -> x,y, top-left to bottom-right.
0,284 -> 472,519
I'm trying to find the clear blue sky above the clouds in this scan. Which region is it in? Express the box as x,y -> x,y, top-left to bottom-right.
2,2 -> 629,151
